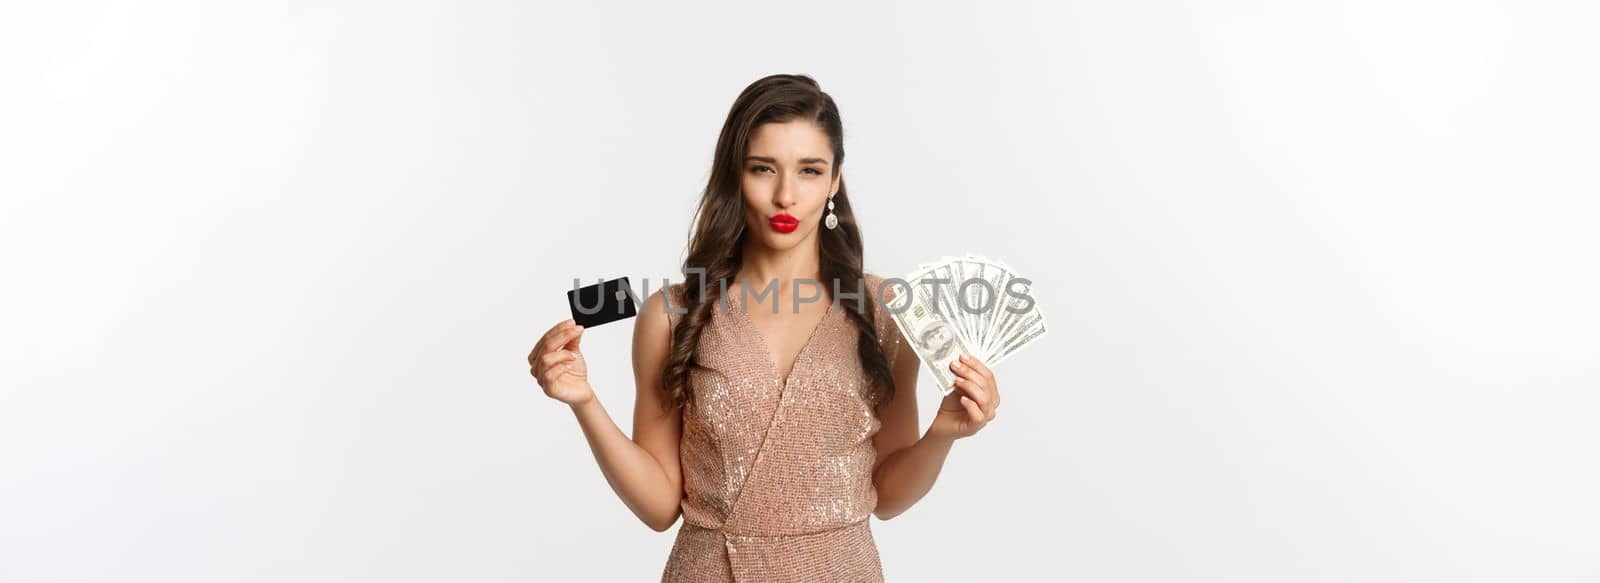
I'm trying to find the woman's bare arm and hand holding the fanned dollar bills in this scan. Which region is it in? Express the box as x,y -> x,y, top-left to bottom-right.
872,346 -> 1000,521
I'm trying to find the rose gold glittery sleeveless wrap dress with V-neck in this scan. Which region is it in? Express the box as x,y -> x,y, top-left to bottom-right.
661,274 -> 901,581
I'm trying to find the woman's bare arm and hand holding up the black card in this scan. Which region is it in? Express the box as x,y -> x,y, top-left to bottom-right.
528,292 -> 683,532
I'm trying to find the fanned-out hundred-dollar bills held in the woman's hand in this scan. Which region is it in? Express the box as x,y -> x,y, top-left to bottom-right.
885,253 -> 1045,394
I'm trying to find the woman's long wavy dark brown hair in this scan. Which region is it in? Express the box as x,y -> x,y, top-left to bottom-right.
662,75 -> 894,407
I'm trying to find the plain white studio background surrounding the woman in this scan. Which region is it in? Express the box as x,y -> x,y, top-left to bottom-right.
0,0 -> 1600,581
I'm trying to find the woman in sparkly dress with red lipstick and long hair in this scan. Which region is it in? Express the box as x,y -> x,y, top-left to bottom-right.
528,75 -> 1000,581
